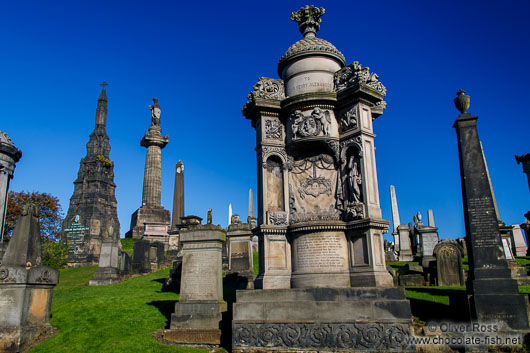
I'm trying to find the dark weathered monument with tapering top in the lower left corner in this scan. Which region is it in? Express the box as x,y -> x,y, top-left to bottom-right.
0,204 -> 59,352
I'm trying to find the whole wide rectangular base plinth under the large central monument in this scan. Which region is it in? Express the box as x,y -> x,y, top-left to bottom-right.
232,288 -> 415,352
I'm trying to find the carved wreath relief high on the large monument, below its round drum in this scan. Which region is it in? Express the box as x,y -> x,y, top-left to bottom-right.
291,107 -> 331,138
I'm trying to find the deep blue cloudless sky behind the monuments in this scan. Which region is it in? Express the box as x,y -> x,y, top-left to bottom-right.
0,0 -> 530,239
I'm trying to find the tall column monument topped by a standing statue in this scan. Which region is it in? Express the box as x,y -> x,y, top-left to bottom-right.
125,98 -> 171,246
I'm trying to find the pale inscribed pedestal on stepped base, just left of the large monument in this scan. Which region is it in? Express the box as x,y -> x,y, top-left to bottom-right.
164,225 -> 227,345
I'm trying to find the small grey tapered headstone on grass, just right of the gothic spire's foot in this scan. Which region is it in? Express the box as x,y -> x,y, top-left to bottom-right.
88,238 -> 120,286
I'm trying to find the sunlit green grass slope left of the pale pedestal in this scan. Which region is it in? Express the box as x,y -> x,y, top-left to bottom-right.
31,266 -> 208,353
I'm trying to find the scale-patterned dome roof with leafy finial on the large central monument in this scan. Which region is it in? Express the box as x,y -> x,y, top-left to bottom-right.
278,5 -> 346,75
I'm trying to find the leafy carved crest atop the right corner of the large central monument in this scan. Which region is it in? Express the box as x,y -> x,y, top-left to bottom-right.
335,61 -> 386,96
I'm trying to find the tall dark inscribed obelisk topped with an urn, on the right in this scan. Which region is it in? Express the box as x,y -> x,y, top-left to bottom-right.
454,90 -> 528,330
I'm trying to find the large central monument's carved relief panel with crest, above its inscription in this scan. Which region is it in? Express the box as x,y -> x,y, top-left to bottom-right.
289,154 -> 340,223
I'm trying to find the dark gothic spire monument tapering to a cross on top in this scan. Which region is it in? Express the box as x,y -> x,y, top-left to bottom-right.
63,82 -> 120,267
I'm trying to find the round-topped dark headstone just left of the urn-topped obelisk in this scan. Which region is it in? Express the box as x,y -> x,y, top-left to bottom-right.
434,239 -> 464,286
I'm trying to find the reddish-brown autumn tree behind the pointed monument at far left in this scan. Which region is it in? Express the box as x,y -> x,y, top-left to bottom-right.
4,191 -> 63,242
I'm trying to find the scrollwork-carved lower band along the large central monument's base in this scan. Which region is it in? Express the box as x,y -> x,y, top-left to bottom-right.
232,322 -> 411,352
